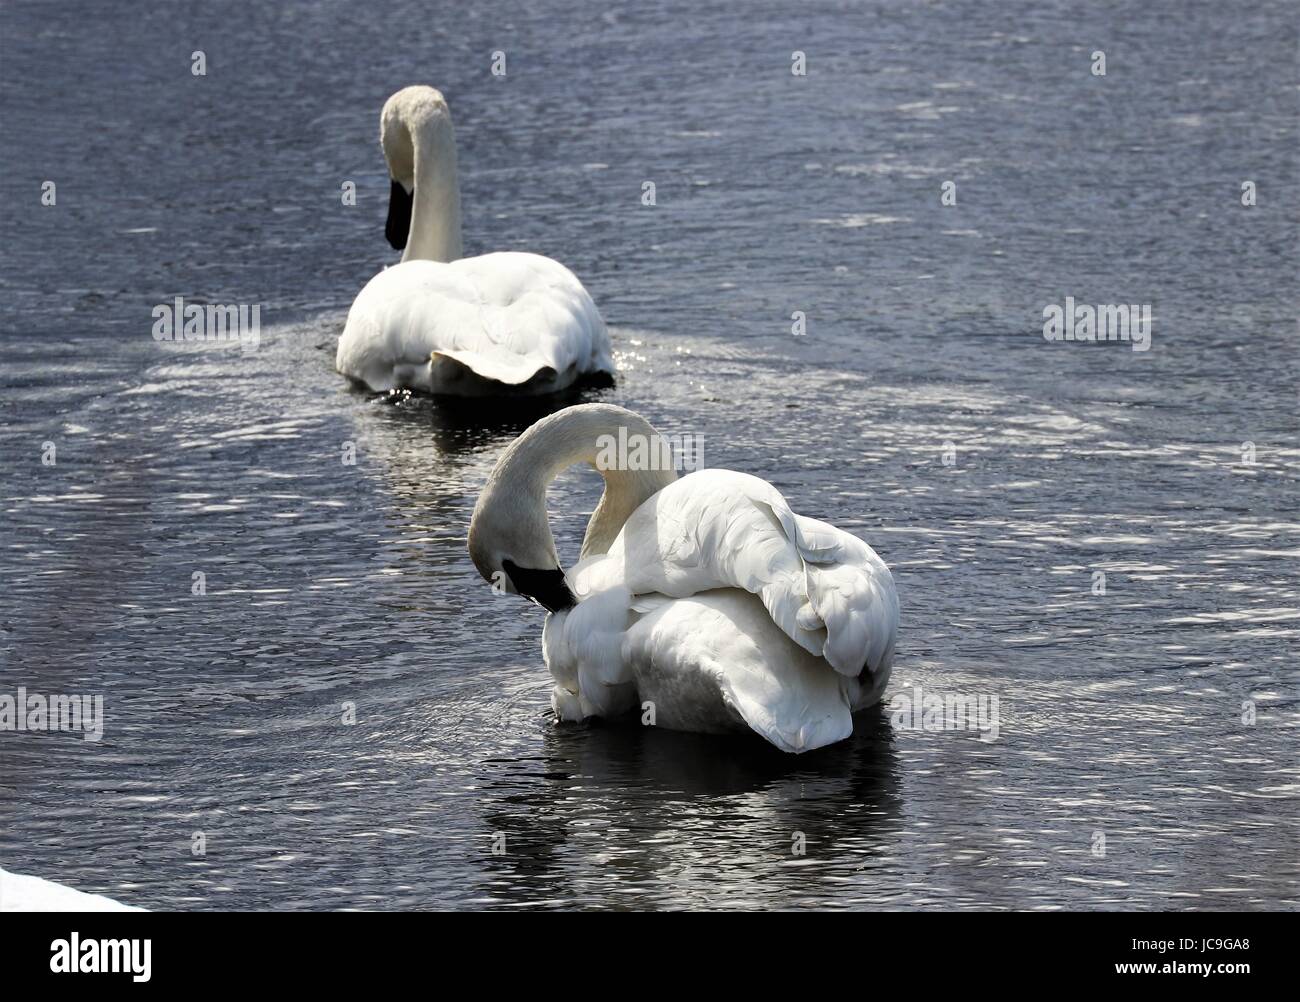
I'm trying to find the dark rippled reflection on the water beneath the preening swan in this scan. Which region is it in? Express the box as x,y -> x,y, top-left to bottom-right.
477,707 -> 902,908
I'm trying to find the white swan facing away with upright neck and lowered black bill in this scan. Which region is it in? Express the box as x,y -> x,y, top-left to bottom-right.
335,87 -> 614,396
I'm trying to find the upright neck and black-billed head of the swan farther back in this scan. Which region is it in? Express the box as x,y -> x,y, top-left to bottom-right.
380,84 -> 460,261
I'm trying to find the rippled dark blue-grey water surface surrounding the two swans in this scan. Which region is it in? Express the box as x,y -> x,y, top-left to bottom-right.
0,0 -> 1300,908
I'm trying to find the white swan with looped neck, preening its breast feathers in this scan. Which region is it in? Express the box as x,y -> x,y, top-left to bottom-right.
468,404 -> 898,752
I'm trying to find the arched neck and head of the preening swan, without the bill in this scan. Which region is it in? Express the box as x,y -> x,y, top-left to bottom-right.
469,404 -> 677,579
